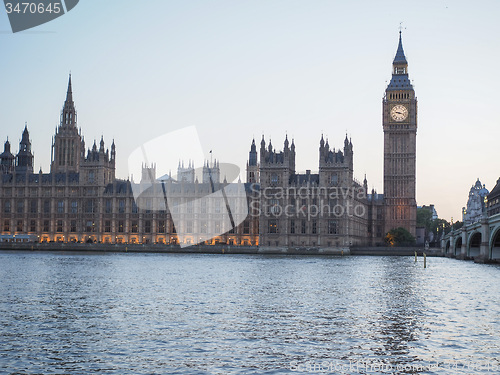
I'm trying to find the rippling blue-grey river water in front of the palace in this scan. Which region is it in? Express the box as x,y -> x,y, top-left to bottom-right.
0,252 -> 500,374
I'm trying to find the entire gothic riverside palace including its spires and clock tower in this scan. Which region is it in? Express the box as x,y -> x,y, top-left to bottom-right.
0,33 -> 417,249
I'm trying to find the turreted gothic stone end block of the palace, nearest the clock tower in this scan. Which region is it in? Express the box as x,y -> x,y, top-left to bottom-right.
247,137 -> 383,248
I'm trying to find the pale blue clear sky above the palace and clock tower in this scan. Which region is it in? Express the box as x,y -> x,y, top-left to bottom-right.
0,0 -> 500,220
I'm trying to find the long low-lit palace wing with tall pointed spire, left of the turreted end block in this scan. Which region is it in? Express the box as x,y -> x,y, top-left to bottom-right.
0,77 -> 258,246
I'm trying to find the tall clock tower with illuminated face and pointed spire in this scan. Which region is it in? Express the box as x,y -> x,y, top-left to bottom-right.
383,31 -> 417,236
